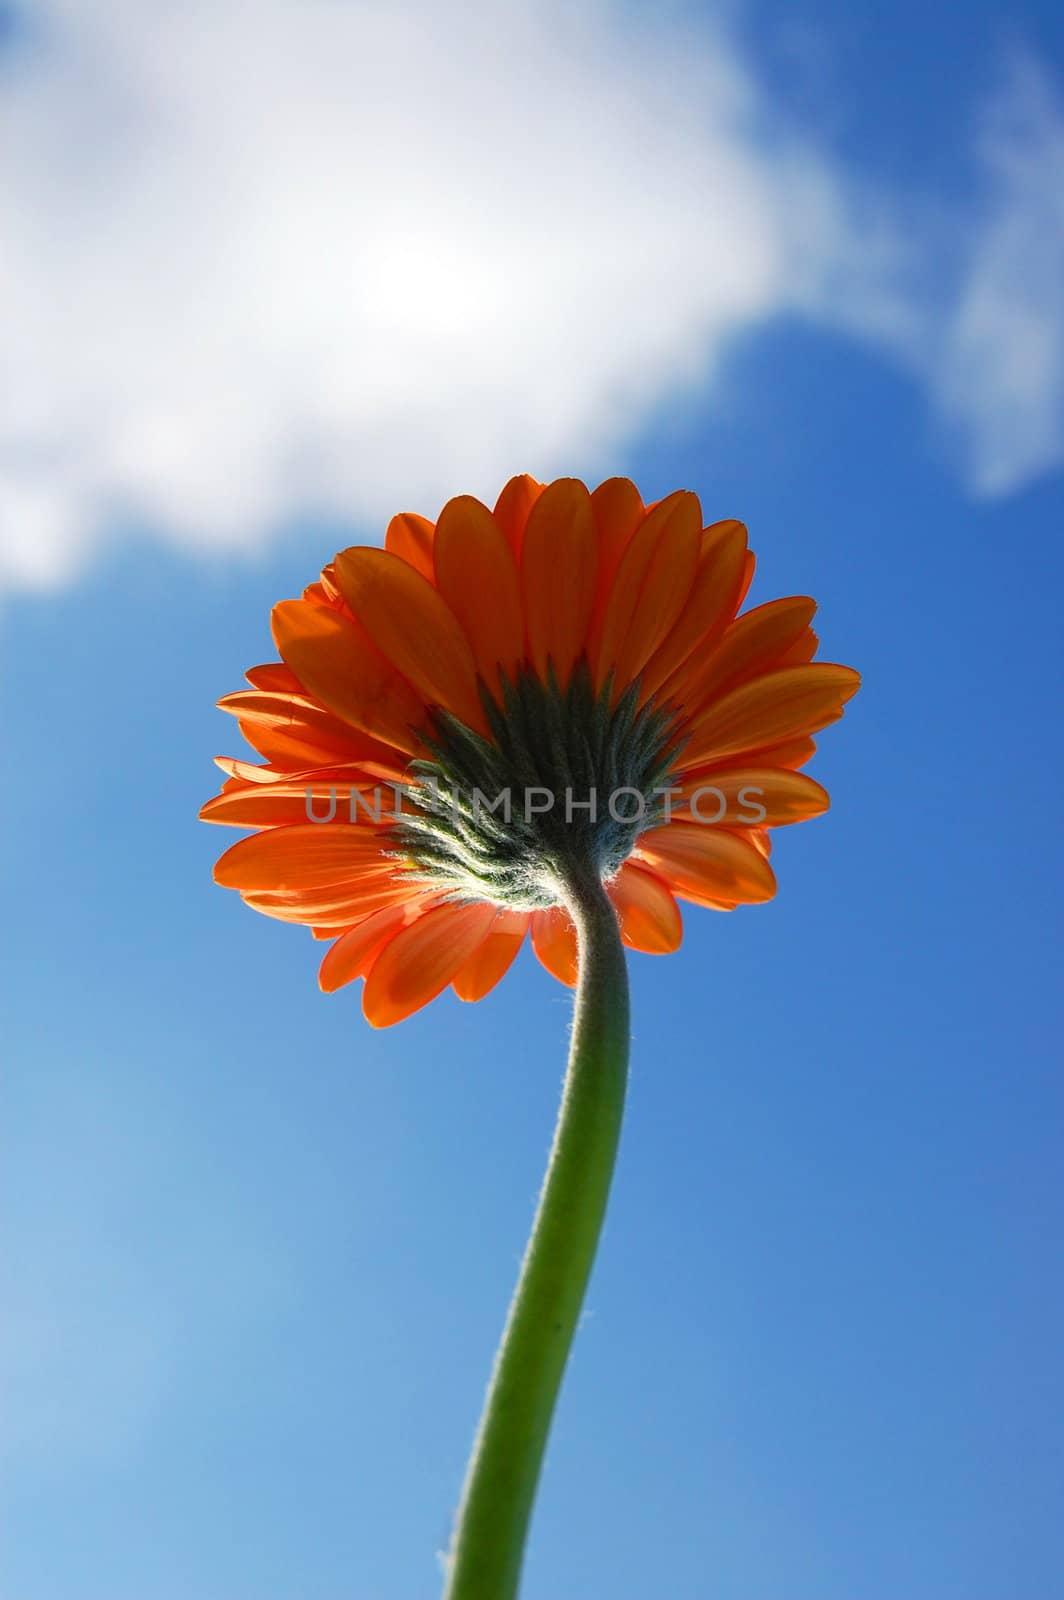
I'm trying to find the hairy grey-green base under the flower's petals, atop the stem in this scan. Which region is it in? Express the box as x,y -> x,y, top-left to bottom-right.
394,661 -> 677,910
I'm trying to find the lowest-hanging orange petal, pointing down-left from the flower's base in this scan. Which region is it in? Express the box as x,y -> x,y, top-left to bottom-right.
362,901 -> 496,1027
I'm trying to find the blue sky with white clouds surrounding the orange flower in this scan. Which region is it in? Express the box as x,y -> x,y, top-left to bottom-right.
0,0 -> 1064,1600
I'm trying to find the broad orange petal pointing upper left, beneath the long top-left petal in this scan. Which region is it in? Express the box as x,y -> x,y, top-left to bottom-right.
272,601 -> 426,752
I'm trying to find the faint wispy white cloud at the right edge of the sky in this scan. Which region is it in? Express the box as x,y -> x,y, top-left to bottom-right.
931,58 -> 1064,494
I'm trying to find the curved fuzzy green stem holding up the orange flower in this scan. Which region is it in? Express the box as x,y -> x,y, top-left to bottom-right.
445,878 -> 629,1600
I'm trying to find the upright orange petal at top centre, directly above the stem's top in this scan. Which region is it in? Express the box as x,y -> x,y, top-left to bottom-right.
522,478 -> 598,688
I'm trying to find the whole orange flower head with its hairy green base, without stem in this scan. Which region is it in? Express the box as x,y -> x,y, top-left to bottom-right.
200,477 -> 859,1027
